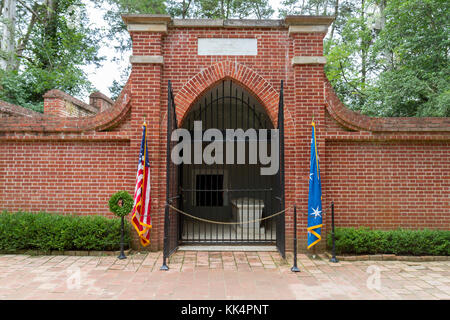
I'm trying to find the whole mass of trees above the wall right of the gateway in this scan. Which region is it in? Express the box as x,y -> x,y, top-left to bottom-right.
280,0 -> 450,117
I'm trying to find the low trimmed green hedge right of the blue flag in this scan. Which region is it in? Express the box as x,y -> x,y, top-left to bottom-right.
327,227 -> 450,256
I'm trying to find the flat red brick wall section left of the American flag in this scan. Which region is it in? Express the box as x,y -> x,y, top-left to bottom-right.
0,141 -> 136,216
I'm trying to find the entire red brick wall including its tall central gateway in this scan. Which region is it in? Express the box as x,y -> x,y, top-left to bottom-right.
0,16 -> 450,250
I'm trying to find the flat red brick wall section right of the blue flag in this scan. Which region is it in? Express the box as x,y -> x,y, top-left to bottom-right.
322,141 -> 450,230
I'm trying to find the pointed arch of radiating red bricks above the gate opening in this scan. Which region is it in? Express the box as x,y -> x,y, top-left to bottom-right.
175,61 -> 280,128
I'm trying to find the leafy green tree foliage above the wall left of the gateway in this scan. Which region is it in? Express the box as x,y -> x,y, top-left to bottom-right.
0,0 -> 103,111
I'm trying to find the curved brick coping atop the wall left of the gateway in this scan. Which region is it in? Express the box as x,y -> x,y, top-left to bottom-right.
0,81 -> 131,133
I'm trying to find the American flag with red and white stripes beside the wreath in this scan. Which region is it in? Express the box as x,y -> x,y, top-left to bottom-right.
131,123 -> 152,247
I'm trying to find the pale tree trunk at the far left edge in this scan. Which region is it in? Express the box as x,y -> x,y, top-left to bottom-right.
0,0 -> 17,70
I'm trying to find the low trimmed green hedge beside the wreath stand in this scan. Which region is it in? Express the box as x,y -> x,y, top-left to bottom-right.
0,212 -> 130,252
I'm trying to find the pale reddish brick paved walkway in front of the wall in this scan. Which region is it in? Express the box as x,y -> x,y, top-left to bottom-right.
0,251 -> 450,299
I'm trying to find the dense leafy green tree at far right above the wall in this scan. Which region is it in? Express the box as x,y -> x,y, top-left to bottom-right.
365,0 -> 450,117
